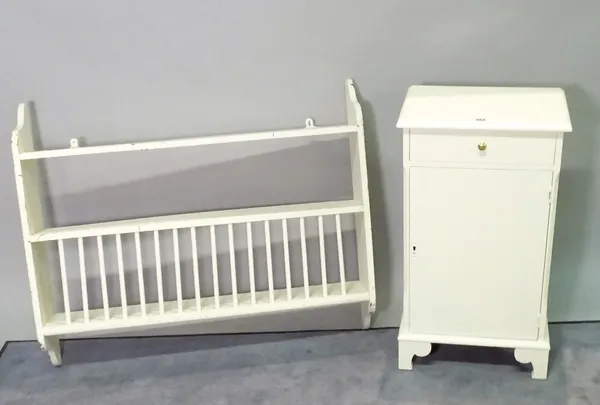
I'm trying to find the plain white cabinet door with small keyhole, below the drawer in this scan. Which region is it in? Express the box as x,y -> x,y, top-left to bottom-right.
409,168 -> 552,339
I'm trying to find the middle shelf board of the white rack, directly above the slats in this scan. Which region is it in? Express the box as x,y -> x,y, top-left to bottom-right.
28,200 -> 363,242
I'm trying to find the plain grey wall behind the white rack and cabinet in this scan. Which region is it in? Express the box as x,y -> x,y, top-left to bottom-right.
0,0 -> 600,344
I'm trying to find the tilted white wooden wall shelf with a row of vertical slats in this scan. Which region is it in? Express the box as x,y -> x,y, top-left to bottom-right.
11,79 -> 376,366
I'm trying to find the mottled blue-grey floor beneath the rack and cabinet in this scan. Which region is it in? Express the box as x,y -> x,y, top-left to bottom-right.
0,323 -> 600,405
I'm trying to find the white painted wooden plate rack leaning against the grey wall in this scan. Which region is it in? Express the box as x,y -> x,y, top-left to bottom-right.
12,79 -> 375,366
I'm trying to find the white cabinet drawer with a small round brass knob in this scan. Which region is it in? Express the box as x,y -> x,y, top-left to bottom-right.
410,130 -> 556,167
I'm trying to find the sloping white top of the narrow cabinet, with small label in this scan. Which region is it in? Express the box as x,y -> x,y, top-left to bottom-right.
396,85 -> 573,132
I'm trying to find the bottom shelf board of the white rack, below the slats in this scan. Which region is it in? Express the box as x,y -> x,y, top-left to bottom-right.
42,281 -> 369,336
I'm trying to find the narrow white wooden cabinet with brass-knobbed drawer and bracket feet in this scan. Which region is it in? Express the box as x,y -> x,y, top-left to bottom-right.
398,86 -> 571,379
